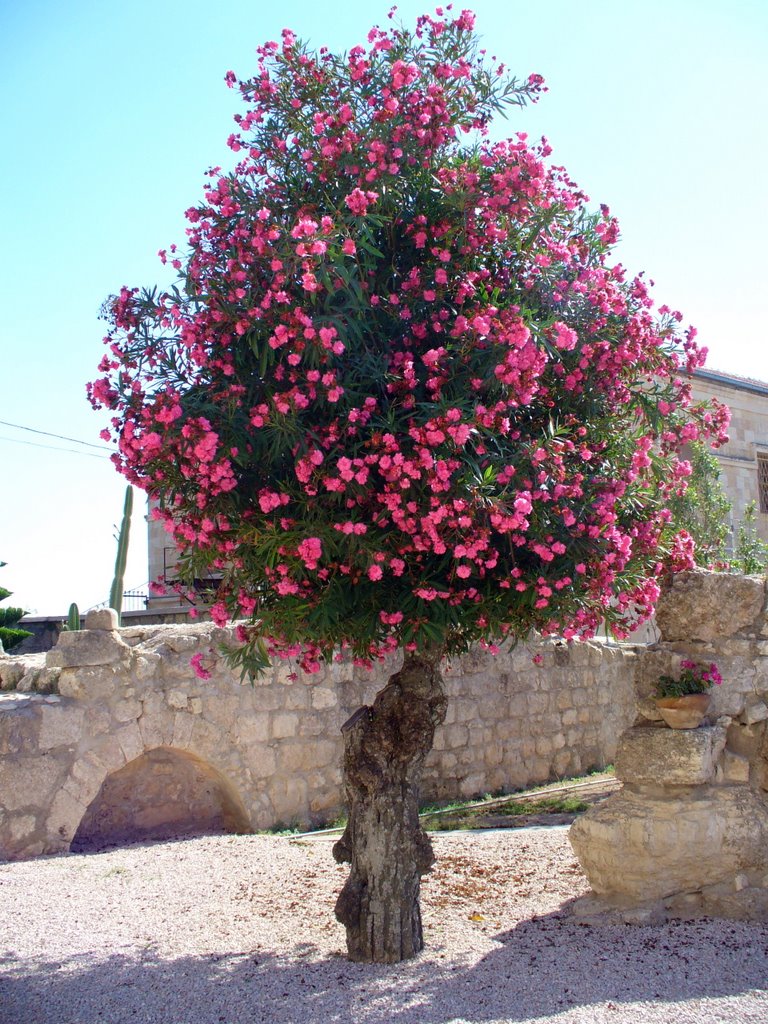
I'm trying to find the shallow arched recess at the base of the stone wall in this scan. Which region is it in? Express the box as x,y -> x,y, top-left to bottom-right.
71,746 -> 251,853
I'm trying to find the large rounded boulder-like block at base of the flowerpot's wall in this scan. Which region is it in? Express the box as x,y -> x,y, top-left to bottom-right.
568,786 -> 768,905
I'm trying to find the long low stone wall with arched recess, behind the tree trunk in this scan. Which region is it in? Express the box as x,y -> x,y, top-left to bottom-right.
0,611 -> 636,858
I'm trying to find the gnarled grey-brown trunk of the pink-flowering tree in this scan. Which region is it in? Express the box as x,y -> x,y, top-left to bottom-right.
333,651 -> 445,964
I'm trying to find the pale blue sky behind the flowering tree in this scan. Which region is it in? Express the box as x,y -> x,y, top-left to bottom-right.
0,0 -> 768,614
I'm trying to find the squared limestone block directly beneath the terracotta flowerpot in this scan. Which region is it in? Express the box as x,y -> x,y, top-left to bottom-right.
615,726 -> 726,785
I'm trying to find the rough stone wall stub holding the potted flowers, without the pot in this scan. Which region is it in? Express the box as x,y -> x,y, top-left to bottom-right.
570,572 -> 768,924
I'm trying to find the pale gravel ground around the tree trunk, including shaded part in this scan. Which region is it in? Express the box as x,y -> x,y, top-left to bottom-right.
0,827 -> 768,1024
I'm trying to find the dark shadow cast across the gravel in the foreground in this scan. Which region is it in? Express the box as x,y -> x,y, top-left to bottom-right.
0,913 -> 768,1024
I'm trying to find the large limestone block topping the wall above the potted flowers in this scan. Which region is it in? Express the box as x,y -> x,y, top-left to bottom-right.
656,570 -> 765,641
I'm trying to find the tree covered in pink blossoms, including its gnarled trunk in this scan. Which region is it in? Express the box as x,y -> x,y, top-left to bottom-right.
90,11 -> 727,962
